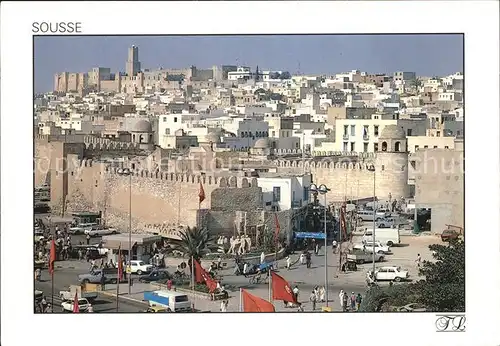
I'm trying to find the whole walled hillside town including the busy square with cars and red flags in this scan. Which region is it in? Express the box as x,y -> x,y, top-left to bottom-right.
34,46 -> 465,313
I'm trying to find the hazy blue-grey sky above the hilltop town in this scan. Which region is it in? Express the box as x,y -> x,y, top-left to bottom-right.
34,35 -> 463,93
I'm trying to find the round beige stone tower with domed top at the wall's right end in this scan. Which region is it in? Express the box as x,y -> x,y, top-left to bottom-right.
374,125 -> 409,199
